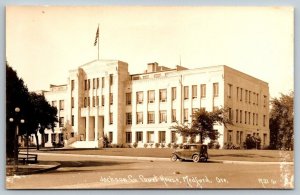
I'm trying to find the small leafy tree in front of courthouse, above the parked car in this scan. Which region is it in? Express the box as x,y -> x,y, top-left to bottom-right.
170,108 -> 232,144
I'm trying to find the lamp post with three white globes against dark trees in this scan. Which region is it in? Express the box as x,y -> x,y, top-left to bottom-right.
9,107 -> 25,172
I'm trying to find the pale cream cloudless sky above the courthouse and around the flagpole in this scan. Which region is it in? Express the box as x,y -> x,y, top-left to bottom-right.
6,6 -> 294,97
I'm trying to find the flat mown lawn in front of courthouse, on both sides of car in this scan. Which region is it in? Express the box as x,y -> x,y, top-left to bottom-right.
26,148 -> 294,162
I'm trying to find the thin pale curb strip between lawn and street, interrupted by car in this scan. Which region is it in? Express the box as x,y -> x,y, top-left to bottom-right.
34,152 -> 294,165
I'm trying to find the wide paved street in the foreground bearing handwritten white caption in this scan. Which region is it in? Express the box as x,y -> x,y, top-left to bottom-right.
6,154 -> 294,189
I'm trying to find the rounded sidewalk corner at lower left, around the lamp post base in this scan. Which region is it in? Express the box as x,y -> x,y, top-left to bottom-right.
6,161 -> 60,176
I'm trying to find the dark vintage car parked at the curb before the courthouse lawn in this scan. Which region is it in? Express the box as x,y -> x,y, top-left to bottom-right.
171,144 -> 208,162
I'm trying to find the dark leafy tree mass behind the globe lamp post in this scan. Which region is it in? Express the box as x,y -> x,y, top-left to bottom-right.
6,62 -> 57,152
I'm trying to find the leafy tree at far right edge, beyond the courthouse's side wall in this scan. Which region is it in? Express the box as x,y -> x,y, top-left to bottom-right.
270,92 -> 294,150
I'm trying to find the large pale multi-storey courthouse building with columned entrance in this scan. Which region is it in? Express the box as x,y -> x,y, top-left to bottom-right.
37,60 -> 270,148
